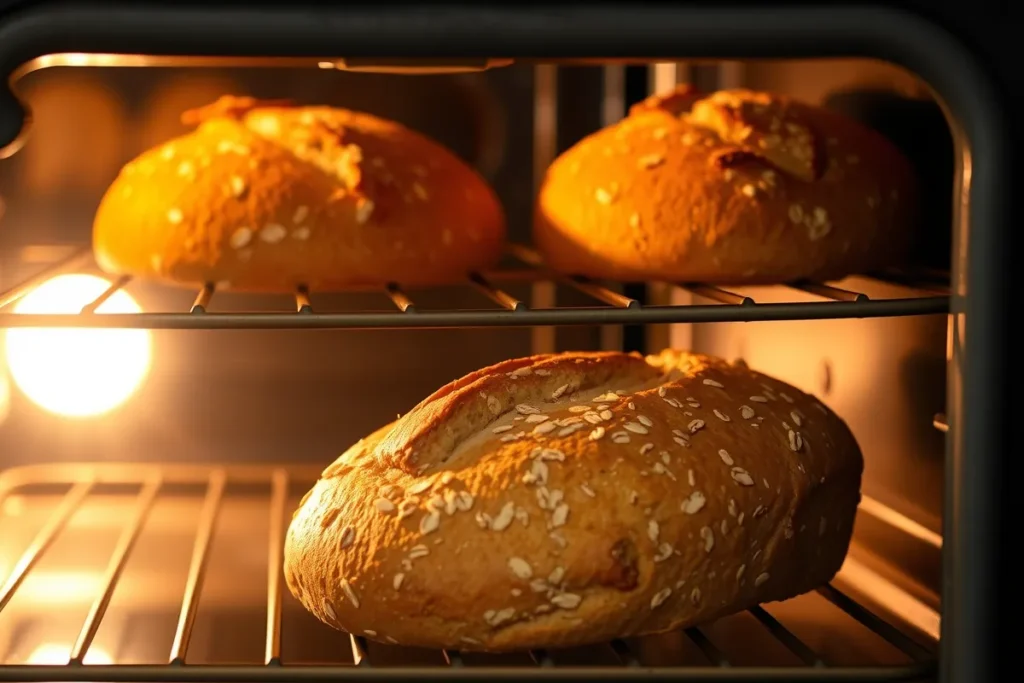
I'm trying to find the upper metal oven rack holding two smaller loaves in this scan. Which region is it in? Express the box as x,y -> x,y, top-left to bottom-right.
0,245 -> 949,330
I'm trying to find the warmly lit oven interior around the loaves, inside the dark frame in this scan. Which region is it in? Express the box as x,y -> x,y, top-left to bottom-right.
0,54 -> 955,681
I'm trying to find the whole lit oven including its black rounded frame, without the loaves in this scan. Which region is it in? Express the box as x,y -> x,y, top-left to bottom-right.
0,3 -> 1010,682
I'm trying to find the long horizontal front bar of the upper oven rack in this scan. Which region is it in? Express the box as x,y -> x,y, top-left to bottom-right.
0,295 -> 949,330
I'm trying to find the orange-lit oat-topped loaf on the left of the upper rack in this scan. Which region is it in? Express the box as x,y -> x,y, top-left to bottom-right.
93,97 -> 505,292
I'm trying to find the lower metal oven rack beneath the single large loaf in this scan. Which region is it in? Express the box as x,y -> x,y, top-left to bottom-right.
0,463 -> 937,683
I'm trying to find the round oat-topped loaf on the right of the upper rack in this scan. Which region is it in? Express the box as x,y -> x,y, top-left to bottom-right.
534,86 -> 916,284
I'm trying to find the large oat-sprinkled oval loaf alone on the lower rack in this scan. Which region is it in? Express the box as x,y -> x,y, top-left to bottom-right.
285,351 -> 863,651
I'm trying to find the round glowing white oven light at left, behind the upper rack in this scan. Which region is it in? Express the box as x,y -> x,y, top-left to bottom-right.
6,274 -> 152,418
